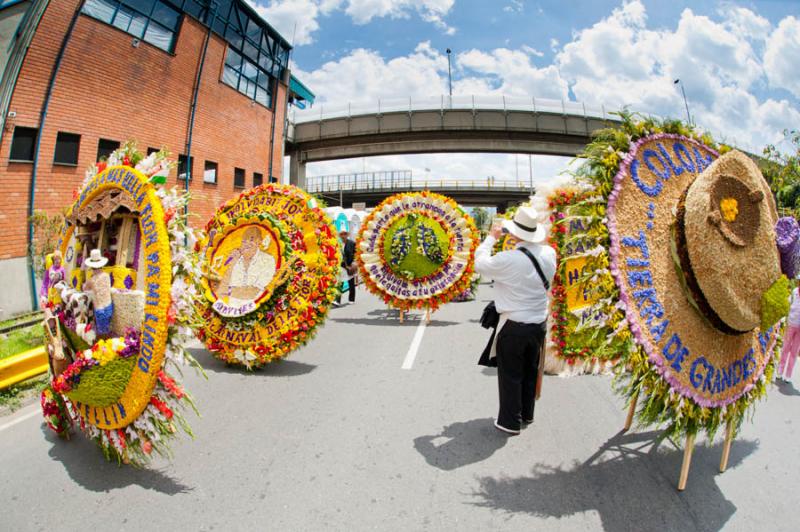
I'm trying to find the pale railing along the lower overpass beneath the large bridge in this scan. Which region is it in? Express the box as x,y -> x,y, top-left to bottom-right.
306,170 -> 531,194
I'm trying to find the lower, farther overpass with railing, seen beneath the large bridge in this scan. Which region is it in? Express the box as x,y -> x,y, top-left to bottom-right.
306,170 -> 532,213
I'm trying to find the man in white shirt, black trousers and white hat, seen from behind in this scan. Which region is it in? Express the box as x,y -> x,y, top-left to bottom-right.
475,207 -> 556,434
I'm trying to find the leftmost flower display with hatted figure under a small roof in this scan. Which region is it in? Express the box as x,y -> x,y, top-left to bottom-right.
41,142 -> 202,465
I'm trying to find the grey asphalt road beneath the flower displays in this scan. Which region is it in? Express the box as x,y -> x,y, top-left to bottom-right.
0,286 -> 800,531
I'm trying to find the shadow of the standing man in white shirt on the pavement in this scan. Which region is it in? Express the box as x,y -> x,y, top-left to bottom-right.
414,418 -> 509,471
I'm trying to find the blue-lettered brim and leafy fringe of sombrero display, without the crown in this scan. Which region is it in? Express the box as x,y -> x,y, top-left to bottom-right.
555,113 -> 780,437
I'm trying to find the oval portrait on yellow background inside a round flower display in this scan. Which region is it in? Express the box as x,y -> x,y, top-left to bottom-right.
212,225 -> 280,316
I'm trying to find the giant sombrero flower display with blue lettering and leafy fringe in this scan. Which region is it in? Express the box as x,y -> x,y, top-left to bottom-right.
553,113 -> 789,437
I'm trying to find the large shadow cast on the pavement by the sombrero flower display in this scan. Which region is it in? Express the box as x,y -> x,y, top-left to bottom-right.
473,432 -> 758,531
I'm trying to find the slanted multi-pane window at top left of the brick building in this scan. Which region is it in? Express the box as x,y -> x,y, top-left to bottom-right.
83,0 -> 181,52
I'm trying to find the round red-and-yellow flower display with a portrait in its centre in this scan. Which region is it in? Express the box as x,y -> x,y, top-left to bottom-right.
197,184 -> 341,368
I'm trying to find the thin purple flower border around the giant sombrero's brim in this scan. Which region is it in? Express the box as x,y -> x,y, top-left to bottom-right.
606,133 -> 777,408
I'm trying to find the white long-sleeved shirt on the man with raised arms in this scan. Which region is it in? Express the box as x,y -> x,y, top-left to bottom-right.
475,236 -> 556,323
